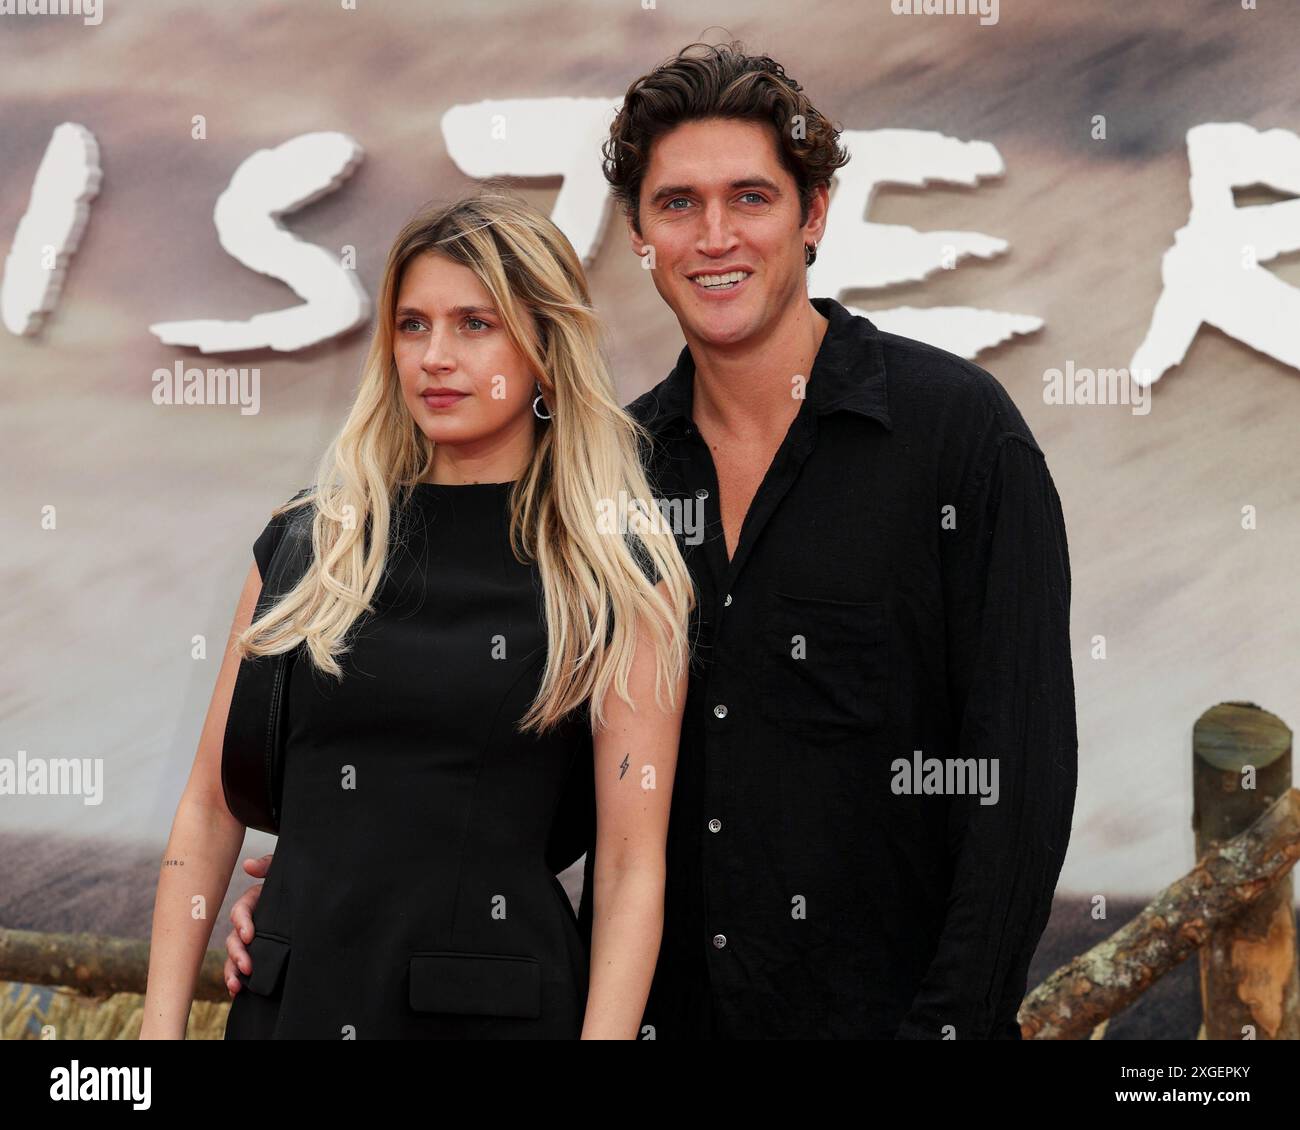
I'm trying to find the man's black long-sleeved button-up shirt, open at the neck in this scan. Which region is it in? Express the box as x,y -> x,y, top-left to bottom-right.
580,298 -> 1076,1039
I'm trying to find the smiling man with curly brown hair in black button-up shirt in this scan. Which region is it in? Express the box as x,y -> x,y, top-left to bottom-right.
590,44 -> 1078,1039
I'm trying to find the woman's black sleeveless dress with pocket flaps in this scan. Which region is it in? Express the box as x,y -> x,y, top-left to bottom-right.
225,482 -> 592,1040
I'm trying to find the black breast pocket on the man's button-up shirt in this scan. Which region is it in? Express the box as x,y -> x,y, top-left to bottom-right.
758,592 -> 889,744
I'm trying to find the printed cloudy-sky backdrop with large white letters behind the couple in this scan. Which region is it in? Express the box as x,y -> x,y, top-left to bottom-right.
0,0 -> 1300,998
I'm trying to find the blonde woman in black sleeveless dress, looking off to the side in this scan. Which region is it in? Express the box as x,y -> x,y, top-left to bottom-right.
140,192 -> 694,1039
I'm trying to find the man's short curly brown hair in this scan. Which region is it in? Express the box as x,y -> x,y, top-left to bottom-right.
601,42 -> 849,235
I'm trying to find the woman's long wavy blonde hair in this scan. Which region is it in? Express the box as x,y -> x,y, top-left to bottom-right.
235,191 -> 694,733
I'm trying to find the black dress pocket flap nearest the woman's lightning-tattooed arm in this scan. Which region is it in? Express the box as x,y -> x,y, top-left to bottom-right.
411,951 -> 542,1019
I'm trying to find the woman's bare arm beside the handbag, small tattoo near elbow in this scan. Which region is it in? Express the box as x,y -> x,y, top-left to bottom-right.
140,566 -> 261,1040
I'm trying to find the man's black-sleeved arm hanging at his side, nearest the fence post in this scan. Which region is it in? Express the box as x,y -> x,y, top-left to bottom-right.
897,433 -> 1078,1040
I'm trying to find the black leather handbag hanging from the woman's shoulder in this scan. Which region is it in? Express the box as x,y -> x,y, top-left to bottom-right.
221,506 -> 316,835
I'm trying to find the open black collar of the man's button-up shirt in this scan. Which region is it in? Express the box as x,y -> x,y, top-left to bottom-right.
645,298 -> 893,436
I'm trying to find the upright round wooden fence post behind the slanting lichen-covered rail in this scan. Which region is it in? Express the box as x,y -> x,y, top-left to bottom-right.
1192,702 -> 1300,1040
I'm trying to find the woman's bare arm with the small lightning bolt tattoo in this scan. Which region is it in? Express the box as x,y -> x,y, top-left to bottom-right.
582,581 -> 686,1040
